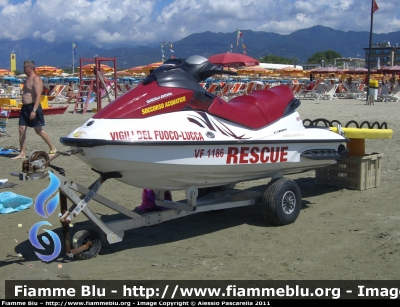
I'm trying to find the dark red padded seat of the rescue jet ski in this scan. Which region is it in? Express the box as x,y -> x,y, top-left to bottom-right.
207,85 -> 299,129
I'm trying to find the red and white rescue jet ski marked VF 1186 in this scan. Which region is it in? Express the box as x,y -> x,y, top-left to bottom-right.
60,55 -> 348,191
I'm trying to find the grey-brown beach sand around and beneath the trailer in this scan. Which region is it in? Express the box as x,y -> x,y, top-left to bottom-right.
0,99 -> 400,298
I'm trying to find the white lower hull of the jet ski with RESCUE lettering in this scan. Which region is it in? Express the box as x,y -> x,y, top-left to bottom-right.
61,111 -> 345,190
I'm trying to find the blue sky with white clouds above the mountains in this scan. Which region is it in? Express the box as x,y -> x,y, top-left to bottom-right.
0,0 -> 400,47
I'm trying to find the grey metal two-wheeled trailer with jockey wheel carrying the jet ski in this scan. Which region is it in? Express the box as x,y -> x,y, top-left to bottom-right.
12,151 -> 301,259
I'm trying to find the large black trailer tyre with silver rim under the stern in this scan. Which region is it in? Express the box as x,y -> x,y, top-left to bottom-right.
261,178 -> 301,226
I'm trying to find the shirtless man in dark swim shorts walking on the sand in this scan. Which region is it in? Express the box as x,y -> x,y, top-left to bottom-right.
11,61 -> 57,160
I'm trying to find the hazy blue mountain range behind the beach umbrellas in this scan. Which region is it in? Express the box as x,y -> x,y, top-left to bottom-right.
0,26 -> 400,70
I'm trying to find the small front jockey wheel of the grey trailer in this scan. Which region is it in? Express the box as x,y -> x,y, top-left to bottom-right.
72,230 -> 101,260
